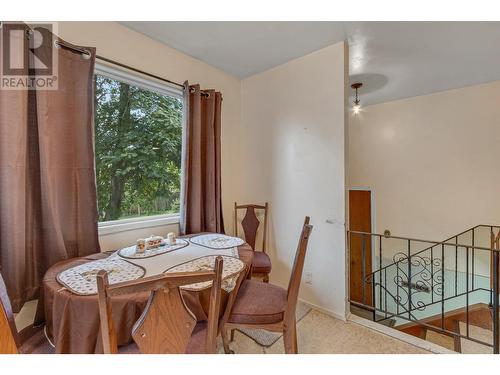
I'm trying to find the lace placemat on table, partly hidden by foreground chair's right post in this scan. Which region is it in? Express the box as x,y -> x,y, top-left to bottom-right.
165,255 -> 245,293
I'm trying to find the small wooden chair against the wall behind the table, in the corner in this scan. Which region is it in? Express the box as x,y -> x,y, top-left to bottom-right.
234,202 -> 272,283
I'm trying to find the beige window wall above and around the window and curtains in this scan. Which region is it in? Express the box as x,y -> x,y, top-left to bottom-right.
58,22 -> 241,251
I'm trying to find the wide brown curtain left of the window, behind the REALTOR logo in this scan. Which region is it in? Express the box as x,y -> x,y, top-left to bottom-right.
0,29 -> 100,311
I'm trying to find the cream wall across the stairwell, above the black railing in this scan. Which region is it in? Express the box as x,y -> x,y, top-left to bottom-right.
348,81 -> 500,266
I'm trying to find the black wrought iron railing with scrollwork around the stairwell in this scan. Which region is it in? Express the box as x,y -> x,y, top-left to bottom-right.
348,225 -> 500,353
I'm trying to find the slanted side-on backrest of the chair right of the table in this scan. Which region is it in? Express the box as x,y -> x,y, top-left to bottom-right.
284,216 -> 313,322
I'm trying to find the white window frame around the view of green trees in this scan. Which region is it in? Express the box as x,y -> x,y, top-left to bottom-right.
94,63 -> 186,236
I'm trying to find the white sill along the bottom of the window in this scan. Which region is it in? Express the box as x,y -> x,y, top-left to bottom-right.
98,214 -> 180,236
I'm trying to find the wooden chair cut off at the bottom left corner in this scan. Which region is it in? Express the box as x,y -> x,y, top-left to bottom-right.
0,274 -> 54,354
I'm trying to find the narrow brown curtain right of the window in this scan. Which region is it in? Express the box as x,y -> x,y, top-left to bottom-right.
181,82 -> 224,234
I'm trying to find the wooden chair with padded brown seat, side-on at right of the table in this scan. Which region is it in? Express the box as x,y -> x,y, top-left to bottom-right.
221,216 -> 313,354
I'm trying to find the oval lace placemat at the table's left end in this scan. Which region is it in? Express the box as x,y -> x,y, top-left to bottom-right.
57,255 -> 146,296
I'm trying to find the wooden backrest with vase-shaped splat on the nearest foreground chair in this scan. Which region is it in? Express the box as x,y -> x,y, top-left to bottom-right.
97,257 -> 223,354
